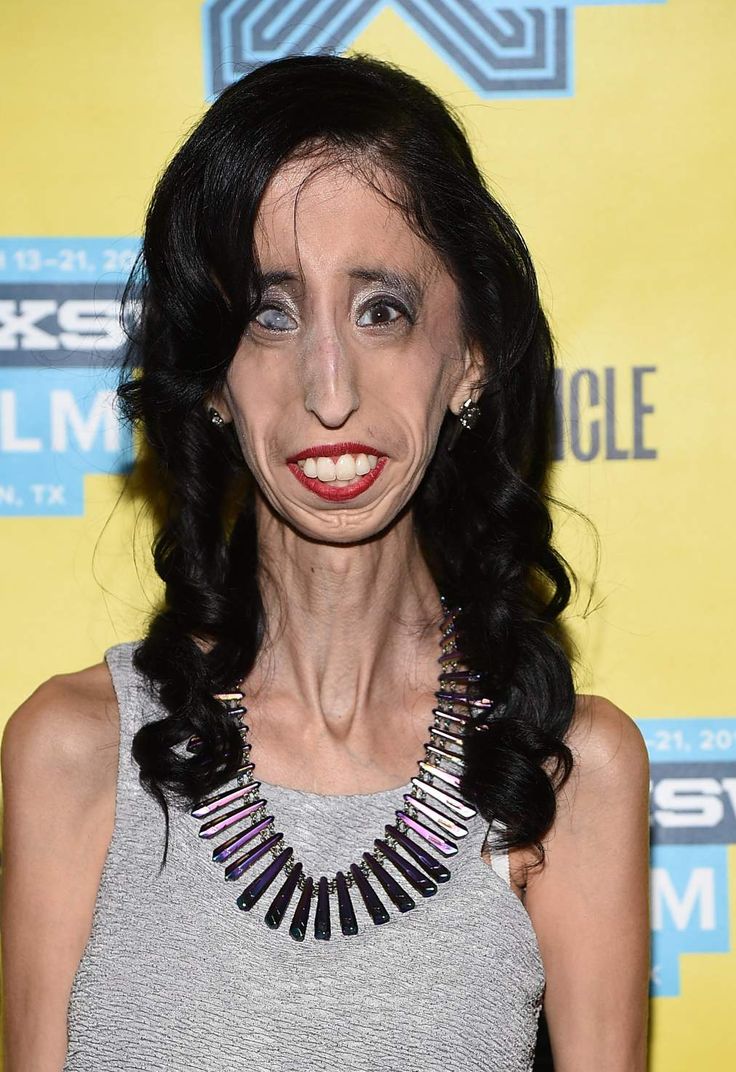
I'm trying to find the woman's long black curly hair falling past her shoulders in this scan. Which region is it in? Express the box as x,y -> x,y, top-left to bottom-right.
118,54 -> 576,866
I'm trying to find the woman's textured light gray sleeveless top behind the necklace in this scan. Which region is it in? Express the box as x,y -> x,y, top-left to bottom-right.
63,641 -> 544,1072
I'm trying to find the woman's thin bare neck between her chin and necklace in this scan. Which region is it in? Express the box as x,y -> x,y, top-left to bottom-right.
249,499 -> 440,741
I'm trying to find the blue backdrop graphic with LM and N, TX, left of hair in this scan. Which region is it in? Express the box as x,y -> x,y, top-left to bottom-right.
0,238 -> 138,517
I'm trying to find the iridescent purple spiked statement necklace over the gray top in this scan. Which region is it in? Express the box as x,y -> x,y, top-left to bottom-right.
187,597 -> 493,941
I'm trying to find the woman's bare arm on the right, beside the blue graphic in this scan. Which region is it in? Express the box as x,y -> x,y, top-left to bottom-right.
526,696 -> 649,1072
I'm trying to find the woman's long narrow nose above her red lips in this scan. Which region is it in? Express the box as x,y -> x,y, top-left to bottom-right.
303,330 -> 359,428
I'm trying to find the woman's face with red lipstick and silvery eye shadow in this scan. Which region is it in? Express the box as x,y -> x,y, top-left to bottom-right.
212,161 -> 479,544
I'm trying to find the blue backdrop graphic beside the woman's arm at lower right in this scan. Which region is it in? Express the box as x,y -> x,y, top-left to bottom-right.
639,718 -> 736,997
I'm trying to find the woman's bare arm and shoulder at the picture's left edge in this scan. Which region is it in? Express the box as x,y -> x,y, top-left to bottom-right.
1,664 -> 118,1072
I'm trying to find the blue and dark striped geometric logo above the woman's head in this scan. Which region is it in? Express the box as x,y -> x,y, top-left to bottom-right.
202,0 -> 666,98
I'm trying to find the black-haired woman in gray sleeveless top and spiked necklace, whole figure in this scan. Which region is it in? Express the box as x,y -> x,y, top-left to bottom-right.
3,56 -> 648,1072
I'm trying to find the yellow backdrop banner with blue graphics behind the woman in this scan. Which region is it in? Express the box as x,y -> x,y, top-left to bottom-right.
0,0 -> 736,1072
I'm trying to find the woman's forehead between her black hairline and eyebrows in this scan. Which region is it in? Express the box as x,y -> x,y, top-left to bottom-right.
255,158 -> 447,282
